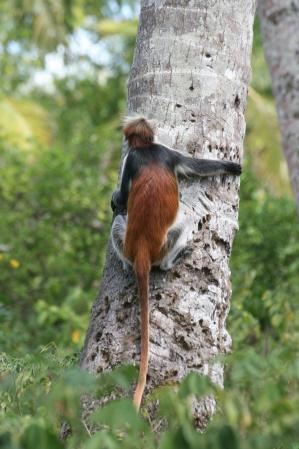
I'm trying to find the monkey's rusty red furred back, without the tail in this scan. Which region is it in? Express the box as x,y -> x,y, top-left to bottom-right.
124,162 -> 179,264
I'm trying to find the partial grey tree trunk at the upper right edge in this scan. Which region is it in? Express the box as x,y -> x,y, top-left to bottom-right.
259,0 -> 299,214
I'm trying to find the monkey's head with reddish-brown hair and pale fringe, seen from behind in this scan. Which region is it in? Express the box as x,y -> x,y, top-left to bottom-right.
123,116 -> 155,148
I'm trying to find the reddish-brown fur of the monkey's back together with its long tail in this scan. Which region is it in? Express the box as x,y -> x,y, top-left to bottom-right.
124,164 -> 179,409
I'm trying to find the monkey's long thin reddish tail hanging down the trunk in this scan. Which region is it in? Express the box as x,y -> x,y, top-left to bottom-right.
133,251 -> 150,411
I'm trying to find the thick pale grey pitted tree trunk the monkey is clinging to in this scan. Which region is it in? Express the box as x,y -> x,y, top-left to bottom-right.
82,0 -> 255,427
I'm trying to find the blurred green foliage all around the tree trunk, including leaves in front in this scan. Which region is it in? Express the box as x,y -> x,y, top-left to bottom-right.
0,0 -> 299,449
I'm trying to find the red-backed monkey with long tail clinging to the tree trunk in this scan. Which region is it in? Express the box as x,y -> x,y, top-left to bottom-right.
111,117 -> 241,410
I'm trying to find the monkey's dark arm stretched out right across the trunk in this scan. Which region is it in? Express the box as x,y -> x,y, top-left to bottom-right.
175,152 -> 242,176
